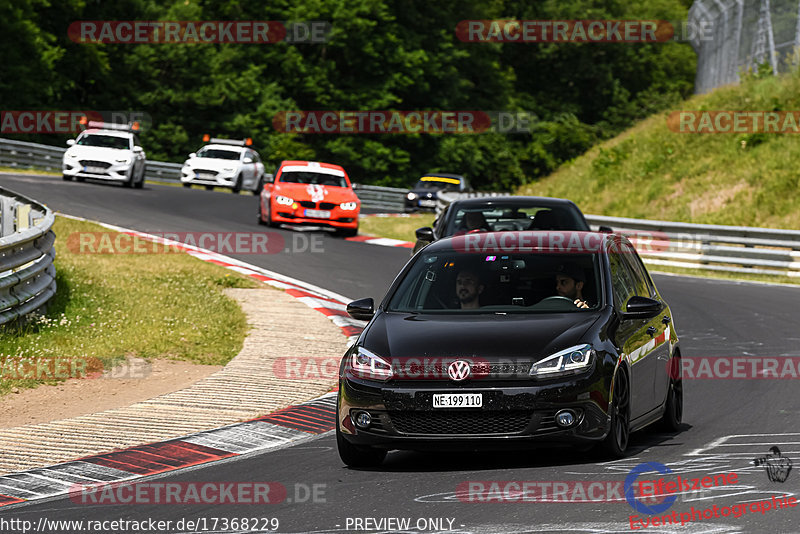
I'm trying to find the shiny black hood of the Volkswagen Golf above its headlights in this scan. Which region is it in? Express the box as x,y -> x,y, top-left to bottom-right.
363,311 -> 601,361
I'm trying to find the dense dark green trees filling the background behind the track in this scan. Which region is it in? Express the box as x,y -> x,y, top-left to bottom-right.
0,0 -> 696,190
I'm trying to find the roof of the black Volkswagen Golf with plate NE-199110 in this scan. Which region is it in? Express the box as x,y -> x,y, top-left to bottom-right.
424,230 -> 620,254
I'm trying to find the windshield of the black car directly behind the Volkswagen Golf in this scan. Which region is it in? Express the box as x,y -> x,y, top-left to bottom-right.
443,205 -> 589,236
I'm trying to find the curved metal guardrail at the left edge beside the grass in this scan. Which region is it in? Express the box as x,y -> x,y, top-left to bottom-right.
0,188 -> 56,324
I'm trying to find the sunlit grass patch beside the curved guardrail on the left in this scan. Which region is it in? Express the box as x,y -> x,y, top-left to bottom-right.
0,217 -> 260,395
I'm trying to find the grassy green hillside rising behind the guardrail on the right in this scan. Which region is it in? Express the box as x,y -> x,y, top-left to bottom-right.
517,68 -> 800,229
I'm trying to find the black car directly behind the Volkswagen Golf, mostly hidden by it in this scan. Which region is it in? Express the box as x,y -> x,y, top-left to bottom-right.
413,196 -> 611,254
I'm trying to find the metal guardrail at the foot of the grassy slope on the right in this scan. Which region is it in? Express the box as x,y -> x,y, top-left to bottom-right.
436,193 -> 800,277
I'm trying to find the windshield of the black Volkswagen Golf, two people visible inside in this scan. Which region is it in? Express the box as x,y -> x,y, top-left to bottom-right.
388,250 -> 601,314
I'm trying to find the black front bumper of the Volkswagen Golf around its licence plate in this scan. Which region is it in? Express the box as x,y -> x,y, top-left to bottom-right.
337,370 -> 610,450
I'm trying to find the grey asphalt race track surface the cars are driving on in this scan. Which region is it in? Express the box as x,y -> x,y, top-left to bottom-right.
0,175 -> 800,533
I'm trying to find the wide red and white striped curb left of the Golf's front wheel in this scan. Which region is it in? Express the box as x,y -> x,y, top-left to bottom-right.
0,392 -> 336,507
